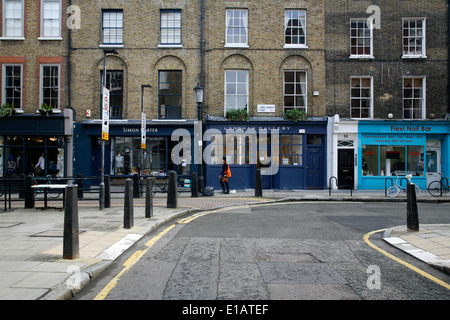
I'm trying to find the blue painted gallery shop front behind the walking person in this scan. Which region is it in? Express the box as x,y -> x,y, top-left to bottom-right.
203,118 -> 328,190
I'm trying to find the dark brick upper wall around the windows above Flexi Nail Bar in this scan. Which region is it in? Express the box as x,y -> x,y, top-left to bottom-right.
325,0 -> 448,119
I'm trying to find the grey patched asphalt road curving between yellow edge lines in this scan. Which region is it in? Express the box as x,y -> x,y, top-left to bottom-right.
74,202 -> 450,302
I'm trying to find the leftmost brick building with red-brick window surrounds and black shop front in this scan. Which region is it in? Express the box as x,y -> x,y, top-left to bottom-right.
0,0 -> 73,176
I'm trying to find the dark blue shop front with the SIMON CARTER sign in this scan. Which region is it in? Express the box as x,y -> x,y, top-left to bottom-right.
74,120 -> 197,177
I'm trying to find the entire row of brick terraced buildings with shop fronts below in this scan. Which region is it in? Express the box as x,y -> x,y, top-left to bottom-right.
0,0 -> 450,189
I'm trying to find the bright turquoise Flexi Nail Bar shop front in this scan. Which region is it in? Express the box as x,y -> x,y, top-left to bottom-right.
358,120 -> 450,189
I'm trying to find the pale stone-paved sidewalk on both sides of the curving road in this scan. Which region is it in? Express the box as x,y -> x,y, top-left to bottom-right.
0,190 -> 450,300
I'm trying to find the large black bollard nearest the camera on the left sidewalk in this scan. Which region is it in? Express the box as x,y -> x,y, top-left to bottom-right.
63,185 -> 80,260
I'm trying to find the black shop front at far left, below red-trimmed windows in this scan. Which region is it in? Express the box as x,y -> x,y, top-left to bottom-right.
0,109 -> 73,177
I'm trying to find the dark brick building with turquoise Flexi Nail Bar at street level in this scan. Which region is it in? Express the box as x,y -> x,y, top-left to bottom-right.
325,0 -> 450,189
